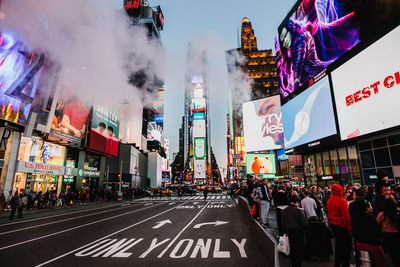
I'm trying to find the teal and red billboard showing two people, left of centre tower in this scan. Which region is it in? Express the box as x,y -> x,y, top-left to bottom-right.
89,105 -> 120,156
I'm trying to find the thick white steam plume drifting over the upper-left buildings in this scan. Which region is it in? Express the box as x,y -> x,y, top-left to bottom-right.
0,0 -> 164,105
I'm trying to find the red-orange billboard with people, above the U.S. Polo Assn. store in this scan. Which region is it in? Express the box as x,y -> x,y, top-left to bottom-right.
48,95 -> 89,147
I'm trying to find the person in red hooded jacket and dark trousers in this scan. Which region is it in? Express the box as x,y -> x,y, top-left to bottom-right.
327,184 -> 351,267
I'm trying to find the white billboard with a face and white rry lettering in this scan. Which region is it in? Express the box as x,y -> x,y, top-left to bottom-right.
243,95 -> 284,152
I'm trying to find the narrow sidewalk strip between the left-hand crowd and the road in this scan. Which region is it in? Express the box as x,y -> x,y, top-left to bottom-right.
0,199 -> 126,224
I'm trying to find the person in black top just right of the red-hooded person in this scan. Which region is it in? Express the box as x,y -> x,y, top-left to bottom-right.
349,195 -> 386,266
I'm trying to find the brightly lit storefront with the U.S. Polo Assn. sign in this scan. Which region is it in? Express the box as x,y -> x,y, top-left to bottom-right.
13,137 -> 66,194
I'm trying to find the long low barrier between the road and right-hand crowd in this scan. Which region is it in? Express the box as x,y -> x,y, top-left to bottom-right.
238,196 -> 279,267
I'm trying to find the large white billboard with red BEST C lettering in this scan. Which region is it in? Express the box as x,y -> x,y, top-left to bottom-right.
332,27 -> 400,140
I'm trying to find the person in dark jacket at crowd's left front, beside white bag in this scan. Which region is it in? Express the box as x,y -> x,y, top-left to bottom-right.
281,196 -> 307,266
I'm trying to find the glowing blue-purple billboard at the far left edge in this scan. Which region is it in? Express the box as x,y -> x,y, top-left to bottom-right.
0,32 -> 57,125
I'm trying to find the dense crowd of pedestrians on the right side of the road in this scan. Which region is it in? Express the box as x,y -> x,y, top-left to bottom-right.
239,172 -> 400,267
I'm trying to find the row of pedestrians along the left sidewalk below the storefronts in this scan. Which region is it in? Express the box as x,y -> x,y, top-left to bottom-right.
0,188 -> 149,220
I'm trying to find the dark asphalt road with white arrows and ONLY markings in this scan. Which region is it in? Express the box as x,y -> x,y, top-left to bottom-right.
0,196 -> 269,267
